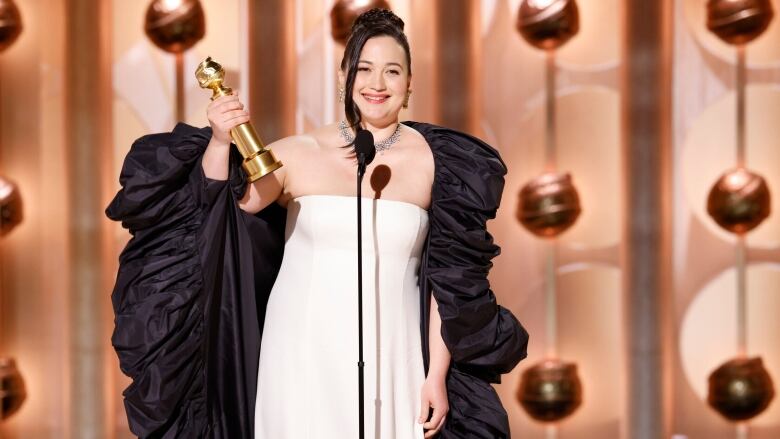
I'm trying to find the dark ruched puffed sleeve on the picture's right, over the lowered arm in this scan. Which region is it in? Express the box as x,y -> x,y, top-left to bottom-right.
409,122 -> 528,438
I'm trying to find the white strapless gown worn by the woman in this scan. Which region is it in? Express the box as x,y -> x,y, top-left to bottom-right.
255,195 -> 428,439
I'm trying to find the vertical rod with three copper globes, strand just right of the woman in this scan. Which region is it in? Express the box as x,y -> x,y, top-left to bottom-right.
515,0 -> 583,426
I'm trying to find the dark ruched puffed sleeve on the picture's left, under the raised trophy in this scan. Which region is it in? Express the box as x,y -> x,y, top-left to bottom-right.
106,124 -> 284,438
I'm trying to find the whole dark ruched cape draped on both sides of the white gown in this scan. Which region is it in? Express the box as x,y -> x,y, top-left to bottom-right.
106,122 -> 528,439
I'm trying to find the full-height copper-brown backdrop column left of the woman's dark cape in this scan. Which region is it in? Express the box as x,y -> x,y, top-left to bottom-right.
64,0 -> 113,439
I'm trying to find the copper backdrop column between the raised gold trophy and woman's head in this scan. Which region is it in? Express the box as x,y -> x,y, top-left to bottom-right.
247,0 -> 296,143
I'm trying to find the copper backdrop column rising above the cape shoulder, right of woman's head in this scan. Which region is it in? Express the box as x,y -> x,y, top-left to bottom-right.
432,0 -> 482,136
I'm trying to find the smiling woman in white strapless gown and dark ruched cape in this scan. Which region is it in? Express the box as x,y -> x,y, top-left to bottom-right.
108,6 -> 527,439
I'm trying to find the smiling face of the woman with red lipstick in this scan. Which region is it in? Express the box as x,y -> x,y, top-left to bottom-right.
344,35 -> 410,126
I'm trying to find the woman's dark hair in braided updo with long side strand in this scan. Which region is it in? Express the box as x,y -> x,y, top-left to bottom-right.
341,8 -> 412,128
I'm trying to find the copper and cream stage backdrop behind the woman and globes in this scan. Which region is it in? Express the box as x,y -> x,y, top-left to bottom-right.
0,0 -> 780,439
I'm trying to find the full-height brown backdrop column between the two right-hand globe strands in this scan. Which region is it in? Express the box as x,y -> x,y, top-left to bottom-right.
622,0 -> 671,439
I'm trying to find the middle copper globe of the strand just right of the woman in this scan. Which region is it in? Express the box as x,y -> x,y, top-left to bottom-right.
517,172 -> 582,238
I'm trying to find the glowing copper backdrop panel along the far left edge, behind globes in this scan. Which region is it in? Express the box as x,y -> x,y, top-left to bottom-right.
0,0 -> 70,439
